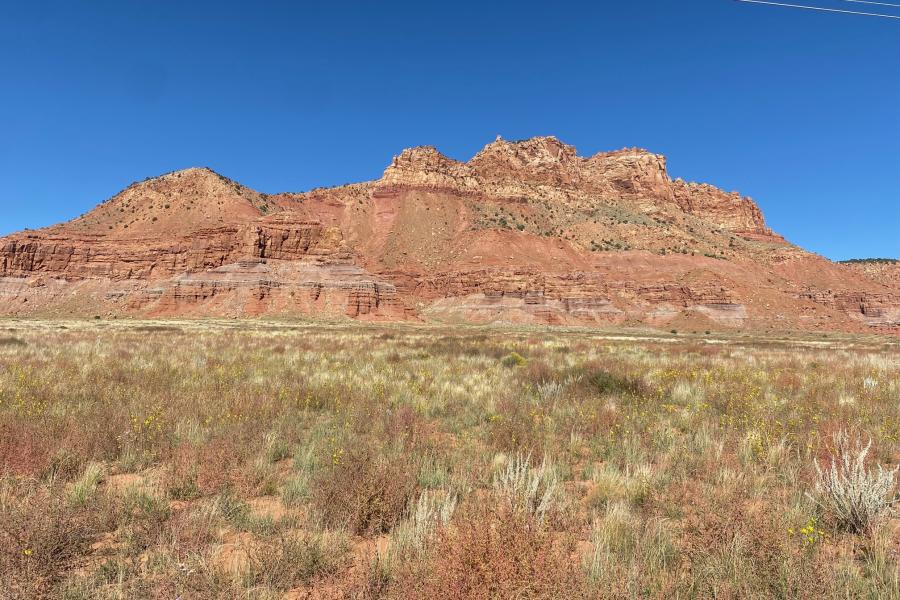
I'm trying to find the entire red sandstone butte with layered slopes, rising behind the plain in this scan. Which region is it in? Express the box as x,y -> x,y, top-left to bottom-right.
0,137 -> 900,333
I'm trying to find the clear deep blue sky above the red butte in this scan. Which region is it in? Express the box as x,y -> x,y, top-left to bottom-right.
0,0 -> 900,259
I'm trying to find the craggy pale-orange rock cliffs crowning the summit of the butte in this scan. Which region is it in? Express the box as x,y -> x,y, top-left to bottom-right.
380,137 -> 771,235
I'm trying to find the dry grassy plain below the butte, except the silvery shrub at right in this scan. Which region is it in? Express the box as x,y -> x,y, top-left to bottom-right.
0,321 -> 900,600
